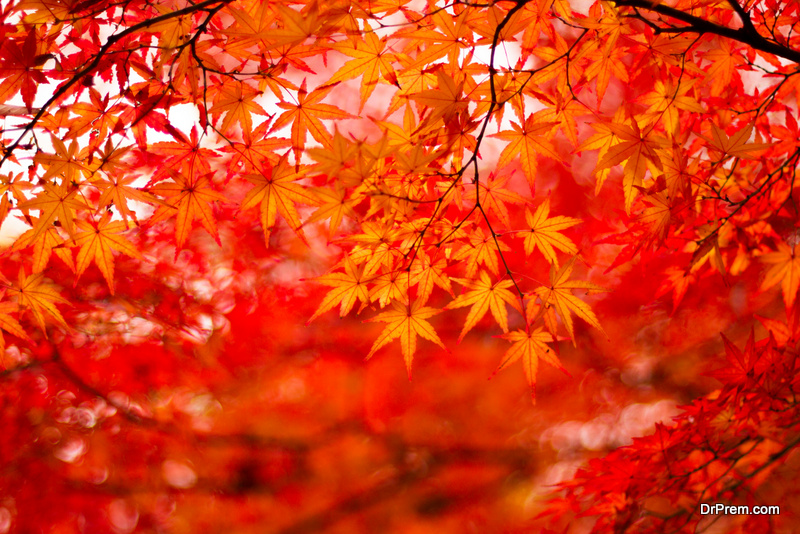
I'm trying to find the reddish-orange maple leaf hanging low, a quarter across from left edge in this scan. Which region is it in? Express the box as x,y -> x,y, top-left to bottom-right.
148,173 -> 225,256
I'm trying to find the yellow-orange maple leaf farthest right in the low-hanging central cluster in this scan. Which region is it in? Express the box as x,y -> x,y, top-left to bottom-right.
535,256 -> 608,345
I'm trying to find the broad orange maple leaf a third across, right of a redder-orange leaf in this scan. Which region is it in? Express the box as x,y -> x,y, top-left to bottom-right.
240,156 -> 320,246
